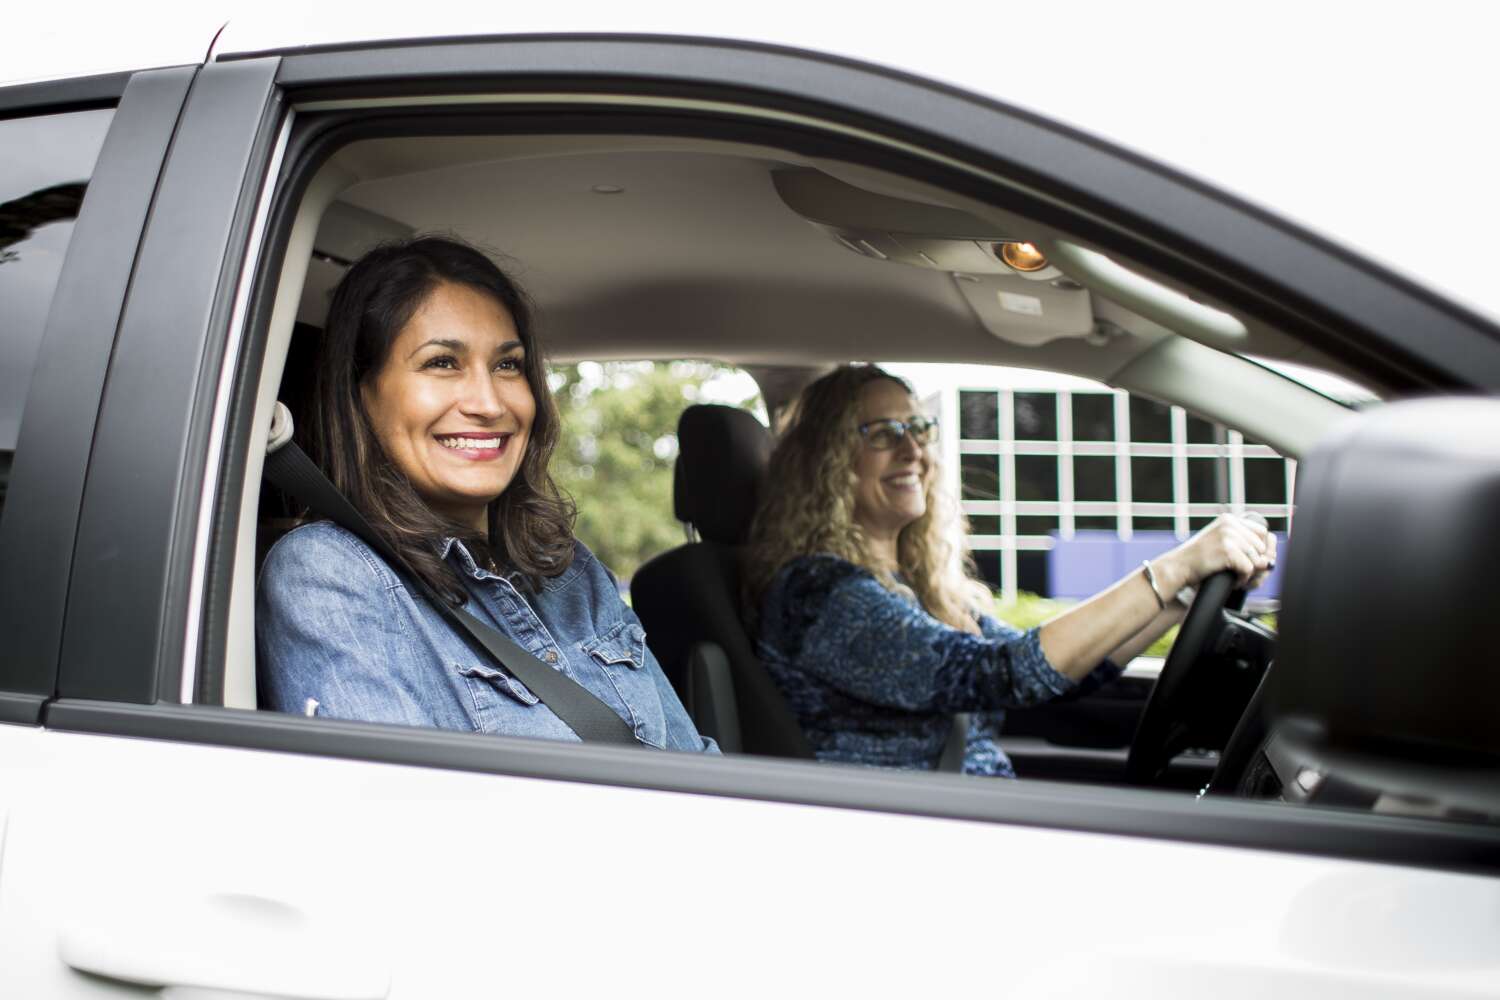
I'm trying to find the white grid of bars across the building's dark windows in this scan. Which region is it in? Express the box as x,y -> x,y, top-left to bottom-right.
945,388 -> 1296,597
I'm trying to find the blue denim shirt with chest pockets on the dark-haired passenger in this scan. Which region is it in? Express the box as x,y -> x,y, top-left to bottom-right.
255,520 -> 719,753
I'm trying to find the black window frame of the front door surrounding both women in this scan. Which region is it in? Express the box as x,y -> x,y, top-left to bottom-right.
32,29 -> 1500,873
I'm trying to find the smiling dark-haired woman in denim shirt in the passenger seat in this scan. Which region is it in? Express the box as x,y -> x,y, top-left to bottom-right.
257,237 -> 714,750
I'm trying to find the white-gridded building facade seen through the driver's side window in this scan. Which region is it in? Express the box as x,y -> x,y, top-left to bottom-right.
893,366 -> 1296,598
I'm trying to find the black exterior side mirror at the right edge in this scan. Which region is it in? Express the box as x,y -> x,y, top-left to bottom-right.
1269,399 -> 1500,757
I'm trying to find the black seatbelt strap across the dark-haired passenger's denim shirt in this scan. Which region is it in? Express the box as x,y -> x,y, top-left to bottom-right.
266,441 -> 641,747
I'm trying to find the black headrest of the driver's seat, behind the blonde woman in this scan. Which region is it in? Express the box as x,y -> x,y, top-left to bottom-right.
672,405 -> 771,546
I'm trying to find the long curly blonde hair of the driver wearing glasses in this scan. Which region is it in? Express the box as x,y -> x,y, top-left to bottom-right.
744,364 -> 989,633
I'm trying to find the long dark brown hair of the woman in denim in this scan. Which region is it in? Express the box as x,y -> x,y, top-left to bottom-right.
309,235 -> 578,604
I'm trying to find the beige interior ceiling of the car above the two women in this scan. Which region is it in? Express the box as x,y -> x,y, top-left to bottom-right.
299,136 -> 1161,379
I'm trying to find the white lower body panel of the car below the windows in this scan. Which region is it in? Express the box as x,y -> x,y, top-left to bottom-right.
0,726 -> 1500,1000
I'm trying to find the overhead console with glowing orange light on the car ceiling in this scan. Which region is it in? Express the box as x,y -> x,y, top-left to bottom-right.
771,169 -> 1092,346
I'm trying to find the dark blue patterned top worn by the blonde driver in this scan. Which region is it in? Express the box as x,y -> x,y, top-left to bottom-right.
758,555 -> 1121,778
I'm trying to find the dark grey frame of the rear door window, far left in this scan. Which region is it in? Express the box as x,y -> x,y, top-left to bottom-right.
0,66 -> 197,724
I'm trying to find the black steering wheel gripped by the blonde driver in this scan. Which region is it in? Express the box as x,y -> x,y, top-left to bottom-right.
1125,570 -> 1235,784
